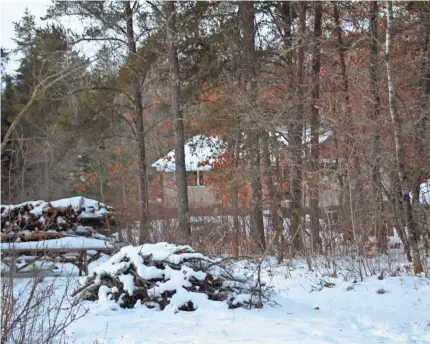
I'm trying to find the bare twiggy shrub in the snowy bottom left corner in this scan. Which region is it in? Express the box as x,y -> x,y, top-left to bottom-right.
0,268 -> 87,344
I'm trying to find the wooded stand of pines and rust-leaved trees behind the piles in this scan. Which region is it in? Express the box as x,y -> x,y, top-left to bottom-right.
1,0 -> 430,272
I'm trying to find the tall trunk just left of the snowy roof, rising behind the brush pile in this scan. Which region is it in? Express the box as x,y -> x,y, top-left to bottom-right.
124,2 -> 150,244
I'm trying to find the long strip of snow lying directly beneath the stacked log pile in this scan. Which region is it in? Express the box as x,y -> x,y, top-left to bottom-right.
0,237 -> 112,250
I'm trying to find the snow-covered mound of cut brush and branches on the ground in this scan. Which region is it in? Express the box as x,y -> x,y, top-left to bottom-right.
73,242 -> 268,312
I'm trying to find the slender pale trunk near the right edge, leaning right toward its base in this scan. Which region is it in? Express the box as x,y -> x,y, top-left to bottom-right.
386,1 -> 423,274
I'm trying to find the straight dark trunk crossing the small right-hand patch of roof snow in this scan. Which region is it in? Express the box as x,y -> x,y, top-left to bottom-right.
309,2 -> 322,253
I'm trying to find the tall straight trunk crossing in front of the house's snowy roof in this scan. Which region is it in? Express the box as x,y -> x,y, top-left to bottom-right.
165,1 -> 191,242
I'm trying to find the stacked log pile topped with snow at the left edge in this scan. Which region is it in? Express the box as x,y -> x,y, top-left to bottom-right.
0,197 -> 115,242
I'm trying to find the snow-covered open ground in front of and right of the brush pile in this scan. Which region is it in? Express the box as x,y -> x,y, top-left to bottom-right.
10,251 -> 430,344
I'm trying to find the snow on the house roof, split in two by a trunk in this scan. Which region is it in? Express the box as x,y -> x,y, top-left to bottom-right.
152,135 -> 226,172
